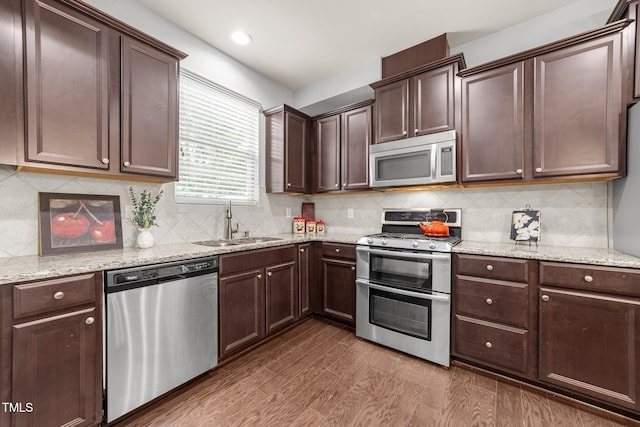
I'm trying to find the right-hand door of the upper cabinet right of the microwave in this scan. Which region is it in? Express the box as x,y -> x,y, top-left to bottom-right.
534,33 -> 626,176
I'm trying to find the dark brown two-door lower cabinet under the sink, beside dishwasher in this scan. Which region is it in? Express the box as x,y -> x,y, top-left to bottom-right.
218,245 -> 299,360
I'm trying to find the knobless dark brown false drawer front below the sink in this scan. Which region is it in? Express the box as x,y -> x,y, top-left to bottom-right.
220,245 -> 296,275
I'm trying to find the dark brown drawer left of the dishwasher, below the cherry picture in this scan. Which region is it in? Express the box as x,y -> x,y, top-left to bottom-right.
13,274 -> 96,319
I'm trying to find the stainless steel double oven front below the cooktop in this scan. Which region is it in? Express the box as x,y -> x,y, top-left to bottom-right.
356,246 -> 451,366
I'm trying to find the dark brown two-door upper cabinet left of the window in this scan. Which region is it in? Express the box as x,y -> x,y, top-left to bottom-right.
10,0 -> 186,181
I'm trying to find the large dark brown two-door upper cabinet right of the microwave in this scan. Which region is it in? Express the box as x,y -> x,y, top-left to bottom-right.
460,22 -> 628,184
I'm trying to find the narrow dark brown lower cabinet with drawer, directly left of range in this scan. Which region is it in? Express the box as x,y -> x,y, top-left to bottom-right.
321,243 -> 356,326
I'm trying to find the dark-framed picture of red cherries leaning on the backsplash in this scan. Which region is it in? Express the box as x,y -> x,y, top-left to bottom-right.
38,193 -> 122,255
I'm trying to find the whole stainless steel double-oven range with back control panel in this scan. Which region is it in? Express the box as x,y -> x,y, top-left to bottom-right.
356,209 -> 462,366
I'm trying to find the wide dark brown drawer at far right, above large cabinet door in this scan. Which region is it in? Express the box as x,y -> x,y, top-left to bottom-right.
540,262 -> 640,296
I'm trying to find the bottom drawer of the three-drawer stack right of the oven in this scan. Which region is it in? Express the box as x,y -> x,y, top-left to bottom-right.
454,316 -> 528,374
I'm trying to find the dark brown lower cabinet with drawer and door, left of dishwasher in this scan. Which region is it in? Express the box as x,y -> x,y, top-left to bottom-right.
0,274 -> 102,426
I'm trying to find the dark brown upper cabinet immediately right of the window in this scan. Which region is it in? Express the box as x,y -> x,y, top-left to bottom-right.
264,105 -> 311,193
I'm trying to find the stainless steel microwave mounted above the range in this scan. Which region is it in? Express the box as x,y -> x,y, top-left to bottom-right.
369,130 -> 456,187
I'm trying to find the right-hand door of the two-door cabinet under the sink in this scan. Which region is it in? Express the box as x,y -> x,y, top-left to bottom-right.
265,262 -> 298,334
